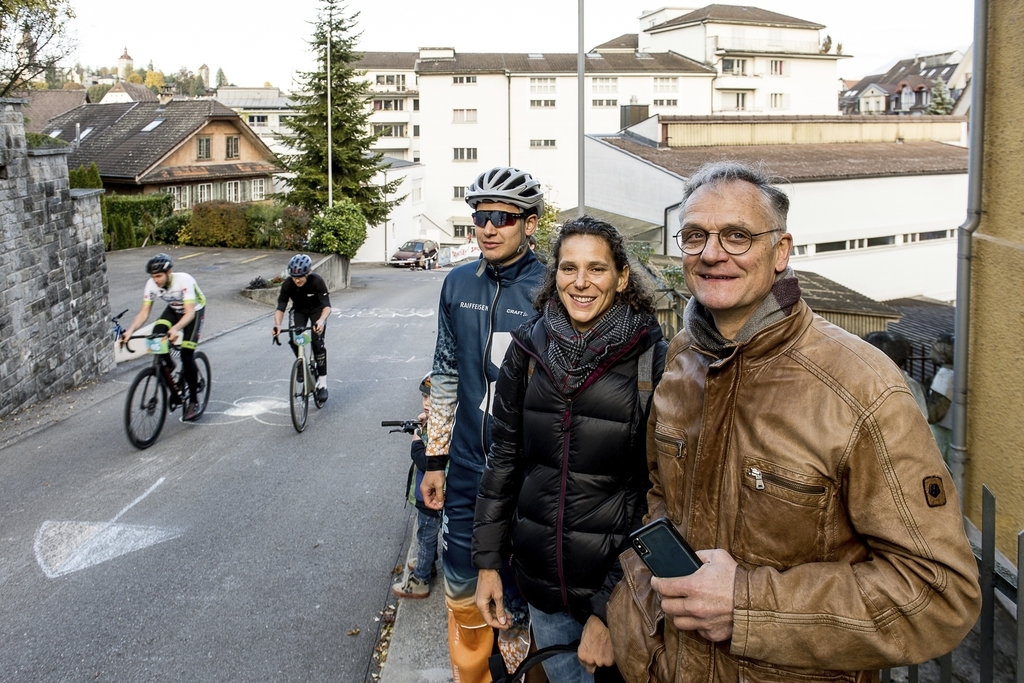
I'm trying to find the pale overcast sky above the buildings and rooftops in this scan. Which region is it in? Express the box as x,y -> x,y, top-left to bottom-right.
72,0 -> 974,90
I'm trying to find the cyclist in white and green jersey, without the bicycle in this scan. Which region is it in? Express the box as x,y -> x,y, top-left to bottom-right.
121,254 -> 206,421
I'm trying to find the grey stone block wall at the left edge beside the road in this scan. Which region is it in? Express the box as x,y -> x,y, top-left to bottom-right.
0,98 -> 114,417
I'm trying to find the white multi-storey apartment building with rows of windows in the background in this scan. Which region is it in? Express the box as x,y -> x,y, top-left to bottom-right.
355,5 -> 842,249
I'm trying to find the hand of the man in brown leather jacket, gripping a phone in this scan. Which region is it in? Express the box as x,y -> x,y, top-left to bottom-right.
650,549 -> 736,643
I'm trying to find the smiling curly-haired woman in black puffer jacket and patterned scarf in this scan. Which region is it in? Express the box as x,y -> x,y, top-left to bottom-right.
473,216 -> 668,682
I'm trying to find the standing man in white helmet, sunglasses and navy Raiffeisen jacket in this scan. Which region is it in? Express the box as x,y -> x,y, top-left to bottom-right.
420,167 -> 544,683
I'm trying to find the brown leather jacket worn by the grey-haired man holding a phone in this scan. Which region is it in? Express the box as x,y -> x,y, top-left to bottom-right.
608,301 -> 981,683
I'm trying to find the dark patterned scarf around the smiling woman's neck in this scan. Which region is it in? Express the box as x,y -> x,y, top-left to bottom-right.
544,297 -> 648,395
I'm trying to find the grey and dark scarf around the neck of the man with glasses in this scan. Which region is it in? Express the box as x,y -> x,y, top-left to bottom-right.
683,267 -> 800,358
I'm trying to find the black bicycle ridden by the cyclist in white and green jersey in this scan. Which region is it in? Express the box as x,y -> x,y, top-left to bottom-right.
111,309 -> 211,450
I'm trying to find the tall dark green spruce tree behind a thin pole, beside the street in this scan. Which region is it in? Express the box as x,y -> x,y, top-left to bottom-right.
281,0 -> 403,225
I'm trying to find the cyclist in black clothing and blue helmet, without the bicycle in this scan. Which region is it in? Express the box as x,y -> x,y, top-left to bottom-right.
273,254 -> 331,403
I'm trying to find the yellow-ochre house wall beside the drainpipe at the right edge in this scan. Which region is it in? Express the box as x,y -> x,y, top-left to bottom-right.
963,0 -> 1024,560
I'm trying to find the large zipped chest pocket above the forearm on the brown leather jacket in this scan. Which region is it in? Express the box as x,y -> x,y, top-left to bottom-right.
732,459 -> 835,570
